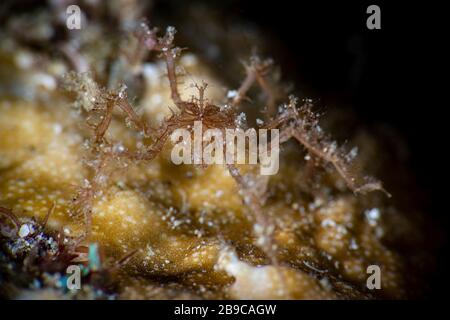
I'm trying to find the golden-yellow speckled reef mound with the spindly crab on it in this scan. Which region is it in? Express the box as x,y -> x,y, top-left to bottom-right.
0,1 -> 436,299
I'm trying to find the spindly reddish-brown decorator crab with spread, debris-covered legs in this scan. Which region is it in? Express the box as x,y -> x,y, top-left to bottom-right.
62,23 -> 384,261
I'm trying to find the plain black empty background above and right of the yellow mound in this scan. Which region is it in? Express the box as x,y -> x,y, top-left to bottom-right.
153,0 -> 449,298
